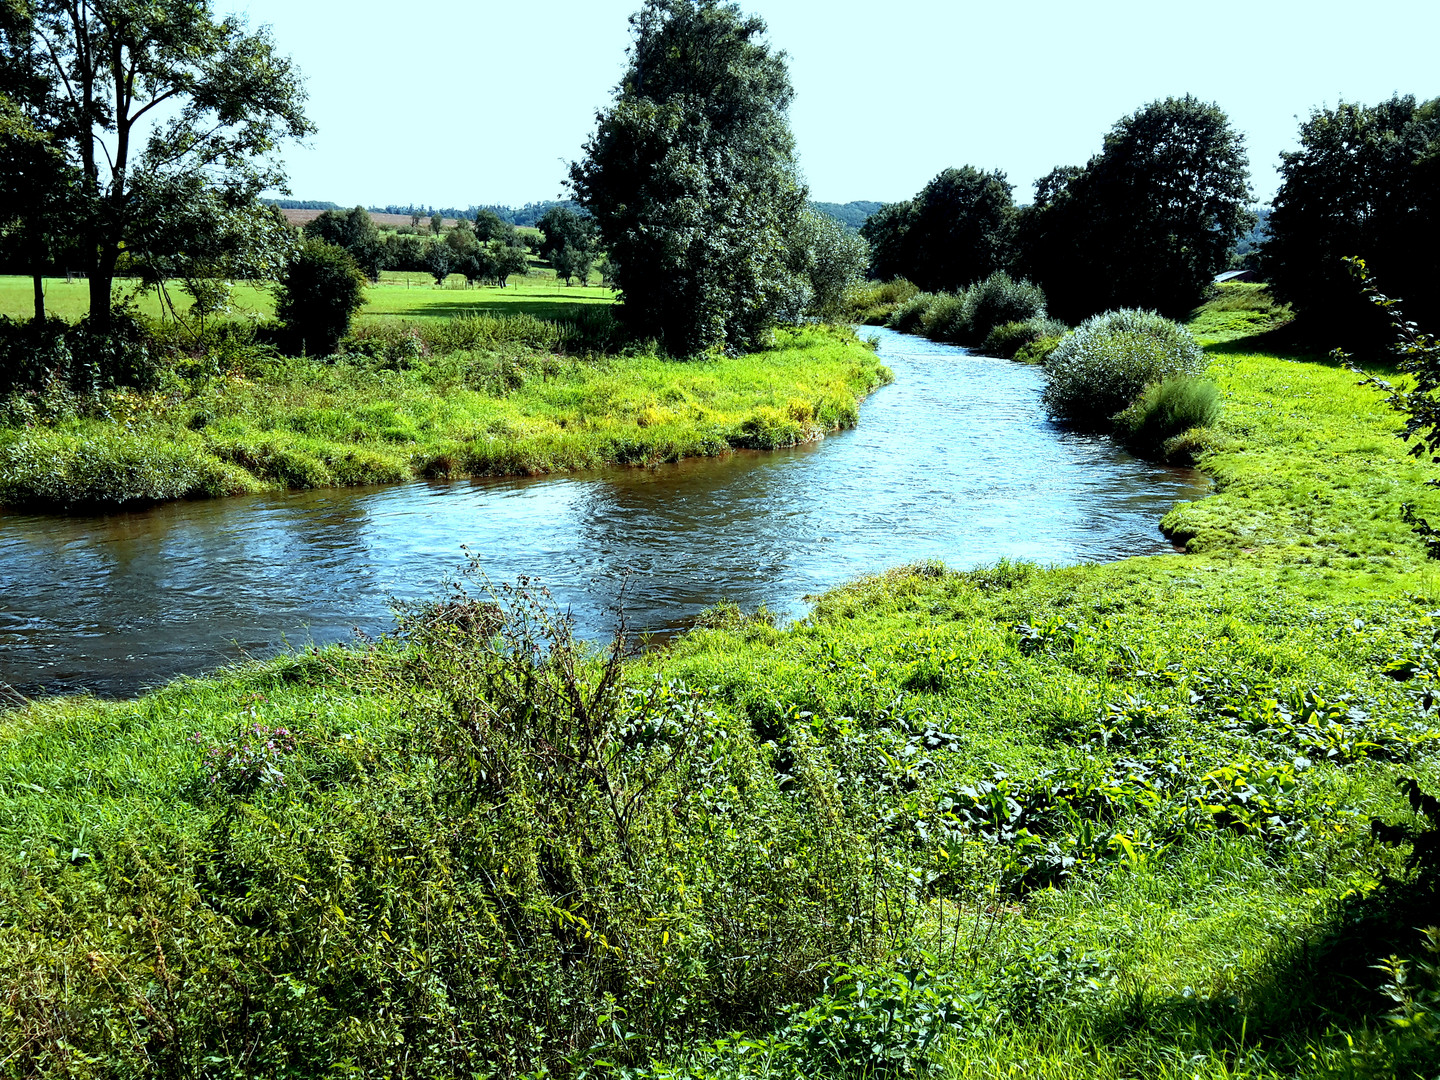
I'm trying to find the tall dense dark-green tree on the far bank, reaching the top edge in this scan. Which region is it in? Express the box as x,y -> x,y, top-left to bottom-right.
570,0 -> 805,356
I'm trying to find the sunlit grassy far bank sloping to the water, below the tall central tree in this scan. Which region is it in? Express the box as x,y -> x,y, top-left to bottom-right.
0,328 -> 890,510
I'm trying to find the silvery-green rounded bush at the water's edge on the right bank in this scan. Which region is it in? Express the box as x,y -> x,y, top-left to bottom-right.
1043,308 -> 1205,431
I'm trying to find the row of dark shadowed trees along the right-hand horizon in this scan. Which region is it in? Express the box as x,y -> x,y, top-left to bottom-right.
861,95 -> 1440,341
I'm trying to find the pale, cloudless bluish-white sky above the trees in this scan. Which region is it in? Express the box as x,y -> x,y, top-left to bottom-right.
236,0 -> 1440,206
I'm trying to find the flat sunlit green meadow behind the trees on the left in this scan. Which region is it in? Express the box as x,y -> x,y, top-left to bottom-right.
0,269 -> 615,321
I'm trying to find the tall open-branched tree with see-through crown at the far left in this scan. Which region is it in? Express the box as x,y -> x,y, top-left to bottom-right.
22,0 -> 311,331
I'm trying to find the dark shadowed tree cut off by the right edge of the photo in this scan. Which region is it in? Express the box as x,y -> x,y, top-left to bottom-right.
1260,95 -> 1440,347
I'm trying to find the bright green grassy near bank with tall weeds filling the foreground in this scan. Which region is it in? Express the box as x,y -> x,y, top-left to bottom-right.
0,289 -> 1440,1080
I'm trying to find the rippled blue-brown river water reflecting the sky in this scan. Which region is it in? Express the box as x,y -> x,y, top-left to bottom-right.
0,331 -> 1207,694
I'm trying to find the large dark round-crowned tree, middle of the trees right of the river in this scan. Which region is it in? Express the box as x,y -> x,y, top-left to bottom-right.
1018,95 -> 1254,318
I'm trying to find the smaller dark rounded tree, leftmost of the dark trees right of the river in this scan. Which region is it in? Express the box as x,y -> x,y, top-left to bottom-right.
860,166 -> 1015,291
